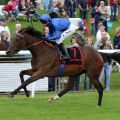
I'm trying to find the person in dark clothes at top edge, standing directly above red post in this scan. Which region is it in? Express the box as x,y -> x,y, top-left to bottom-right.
78,0 -> 88,20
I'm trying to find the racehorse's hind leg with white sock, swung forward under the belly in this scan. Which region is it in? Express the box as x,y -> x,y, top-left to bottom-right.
48,76 -> 77,102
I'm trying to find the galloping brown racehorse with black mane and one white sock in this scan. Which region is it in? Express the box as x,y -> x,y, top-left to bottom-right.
7,27 -> 120,106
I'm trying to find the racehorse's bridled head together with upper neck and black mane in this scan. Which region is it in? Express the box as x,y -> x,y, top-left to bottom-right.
7,27 -> 42,56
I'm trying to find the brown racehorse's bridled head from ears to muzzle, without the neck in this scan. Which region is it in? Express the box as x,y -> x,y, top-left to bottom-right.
6,29 -> 25,56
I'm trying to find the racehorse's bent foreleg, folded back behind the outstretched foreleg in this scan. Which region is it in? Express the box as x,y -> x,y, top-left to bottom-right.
19,69 -> 32,97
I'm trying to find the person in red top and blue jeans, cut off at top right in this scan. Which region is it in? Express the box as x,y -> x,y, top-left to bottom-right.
109,0 -> 118,21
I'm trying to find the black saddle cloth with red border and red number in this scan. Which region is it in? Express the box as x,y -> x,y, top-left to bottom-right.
65,47 -> 83,65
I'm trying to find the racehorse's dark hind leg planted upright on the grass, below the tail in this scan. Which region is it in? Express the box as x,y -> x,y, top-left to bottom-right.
90,78 -> 103,106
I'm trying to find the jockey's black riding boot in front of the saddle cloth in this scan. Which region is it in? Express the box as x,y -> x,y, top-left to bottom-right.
59,43 -> 70,60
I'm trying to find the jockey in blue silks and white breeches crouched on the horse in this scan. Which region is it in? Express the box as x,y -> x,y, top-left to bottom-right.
40,14 -> 75,59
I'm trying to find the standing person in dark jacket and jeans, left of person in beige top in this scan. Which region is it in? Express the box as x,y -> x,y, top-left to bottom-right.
90,4 -> 101,35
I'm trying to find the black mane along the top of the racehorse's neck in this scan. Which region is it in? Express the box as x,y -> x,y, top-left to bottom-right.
25,27 -> 43,39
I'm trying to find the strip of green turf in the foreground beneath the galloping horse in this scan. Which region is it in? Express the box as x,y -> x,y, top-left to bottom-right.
0,91 -> 120,120
